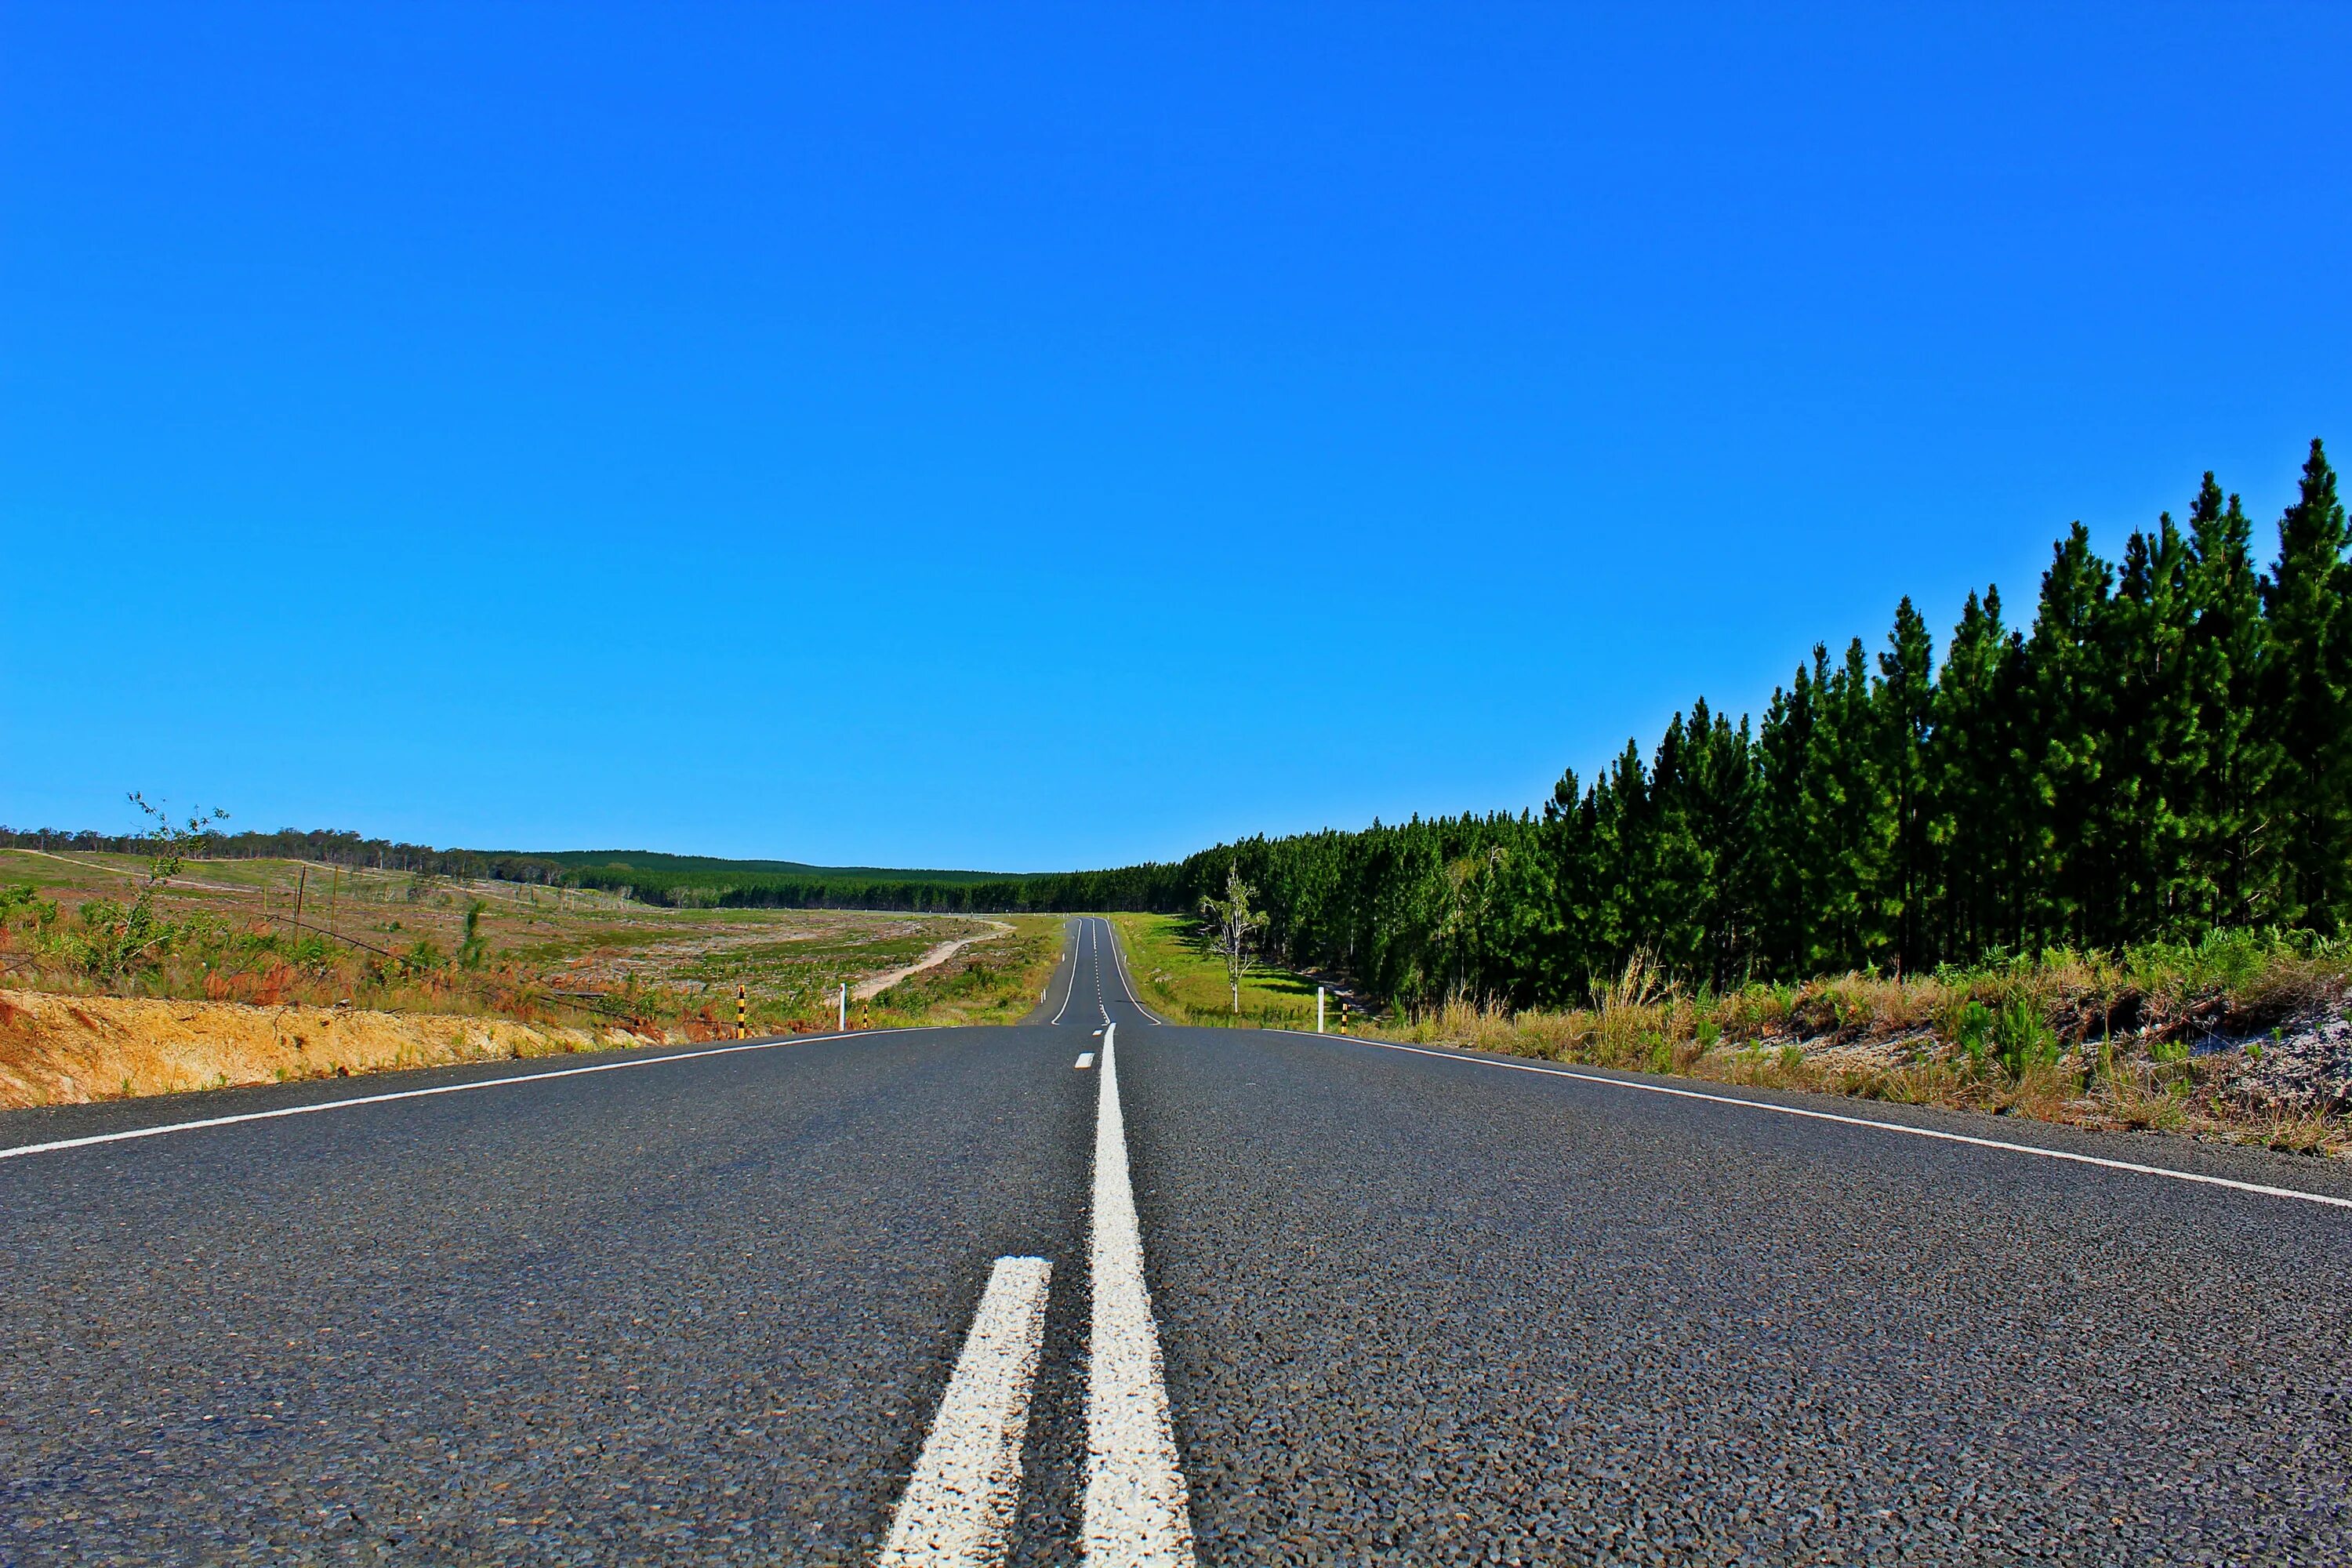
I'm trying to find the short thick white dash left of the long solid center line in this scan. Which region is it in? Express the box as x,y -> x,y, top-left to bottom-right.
880,1258 -> 1054,1568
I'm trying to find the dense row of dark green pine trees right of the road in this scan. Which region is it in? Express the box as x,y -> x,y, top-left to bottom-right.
1176,442 -> 2352,1004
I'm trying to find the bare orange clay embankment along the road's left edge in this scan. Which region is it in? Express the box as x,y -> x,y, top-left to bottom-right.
0,989 -> 659,1107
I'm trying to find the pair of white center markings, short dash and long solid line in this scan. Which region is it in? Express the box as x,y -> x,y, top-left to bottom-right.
880,1025 -> 1192,1568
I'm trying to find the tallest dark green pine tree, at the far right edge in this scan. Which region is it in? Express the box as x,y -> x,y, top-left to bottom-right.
2263,442 -> 2352,931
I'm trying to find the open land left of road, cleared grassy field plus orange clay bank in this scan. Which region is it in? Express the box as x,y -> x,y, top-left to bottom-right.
0,851 -> 1061,1105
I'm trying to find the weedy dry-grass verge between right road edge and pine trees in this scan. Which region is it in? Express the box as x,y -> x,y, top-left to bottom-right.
1378,933 -> 2352,1156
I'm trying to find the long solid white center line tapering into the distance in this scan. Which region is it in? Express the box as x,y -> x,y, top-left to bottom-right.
1082,1025 -> 1192,1568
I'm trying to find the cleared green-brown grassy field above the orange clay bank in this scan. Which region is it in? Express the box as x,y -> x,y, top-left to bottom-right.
0,851 -> 997,1039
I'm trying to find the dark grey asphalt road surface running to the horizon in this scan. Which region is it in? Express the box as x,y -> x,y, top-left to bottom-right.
0,921 -> 2352,1566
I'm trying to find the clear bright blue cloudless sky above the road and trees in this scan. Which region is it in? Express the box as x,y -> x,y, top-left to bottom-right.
0,0 -> 2352,869
